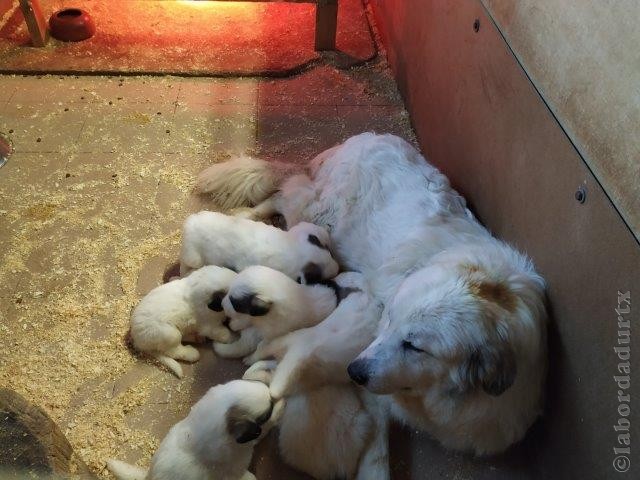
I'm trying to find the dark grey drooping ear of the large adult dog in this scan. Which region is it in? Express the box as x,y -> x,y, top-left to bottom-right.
458,342 -> 517,397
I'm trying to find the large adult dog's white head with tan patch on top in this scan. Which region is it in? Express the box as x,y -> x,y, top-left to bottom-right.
348,245 -> 546,397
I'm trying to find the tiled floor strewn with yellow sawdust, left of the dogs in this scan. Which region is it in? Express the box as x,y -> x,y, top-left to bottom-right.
0,65 -> 420,479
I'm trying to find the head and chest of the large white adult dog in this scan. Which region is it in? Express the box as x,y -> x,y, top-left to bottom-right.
348,244 -> 546,454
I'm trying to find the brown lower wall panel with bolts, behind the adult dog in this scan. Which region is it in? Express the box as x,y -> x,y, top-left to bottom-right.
372,0 -> 640,480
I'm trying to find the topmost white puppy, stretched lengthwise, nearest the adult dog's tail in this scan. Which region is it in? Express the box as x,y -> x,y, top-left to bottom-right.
180,211 -> 338,282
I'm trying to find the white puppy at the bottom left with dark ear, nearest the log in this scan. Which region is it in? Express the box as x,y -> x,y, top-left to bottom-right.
107,380 -> 284,480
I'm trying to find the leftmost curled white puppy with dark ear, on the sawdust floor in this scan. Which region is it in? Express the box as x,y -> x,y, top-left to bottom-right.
131,266 -> 237,378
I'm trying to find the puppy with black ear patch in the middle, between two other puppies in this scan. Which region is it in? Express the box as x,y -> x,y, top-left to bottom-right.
222,265 -> 340,365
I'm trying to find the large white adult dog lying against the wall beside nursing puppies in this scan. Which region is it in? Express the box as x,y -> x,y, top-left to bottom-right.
199,133 -> 546,454
